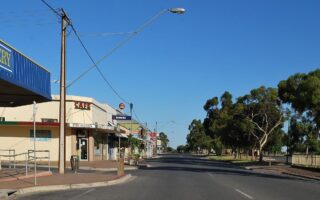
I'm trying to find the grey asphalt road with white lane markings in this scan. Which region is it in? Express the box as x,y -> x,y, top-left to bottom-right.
16,155 -> 320,200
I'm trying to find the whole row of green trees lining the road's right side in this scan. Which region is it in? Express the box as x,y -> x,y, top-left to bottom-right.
179,69 -> 320,158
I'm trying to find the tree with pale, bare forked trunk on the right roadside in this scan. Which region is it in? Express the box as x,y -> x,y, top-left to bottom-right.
238,86 -> 284,162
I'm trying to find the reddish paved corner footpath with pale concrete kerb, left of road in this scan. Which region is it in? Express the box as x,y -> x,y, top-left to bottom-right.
0,161 -> 138,199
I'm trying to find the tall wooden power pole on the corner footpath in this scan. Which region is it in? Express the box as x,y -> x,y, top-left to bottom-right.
59,9 -> 70,174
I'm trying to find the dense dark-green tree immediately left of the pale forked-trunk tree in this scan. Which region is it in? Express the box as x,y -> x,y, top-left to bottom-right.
203,91 -> 252,155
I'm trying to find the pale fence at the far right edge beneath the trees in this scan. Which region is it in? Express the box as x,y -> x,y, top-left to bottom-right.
292,154 -> 320,168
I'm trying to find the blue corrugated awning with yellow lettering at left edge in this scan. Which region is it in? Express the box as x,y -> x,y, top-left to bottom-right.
0,40 -> 51,107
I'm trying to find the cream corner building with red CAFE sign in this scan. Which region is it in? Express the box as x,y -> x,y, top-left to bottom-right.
0,96 -> 128,161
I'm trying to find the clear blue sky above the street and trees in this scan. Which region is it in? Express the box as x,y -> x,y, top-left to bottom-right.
0,0 -> 320,147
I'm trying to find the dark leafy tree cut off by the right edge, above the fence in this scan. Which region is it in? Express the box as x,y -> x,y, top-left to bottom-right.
278,69 -> 320,154
